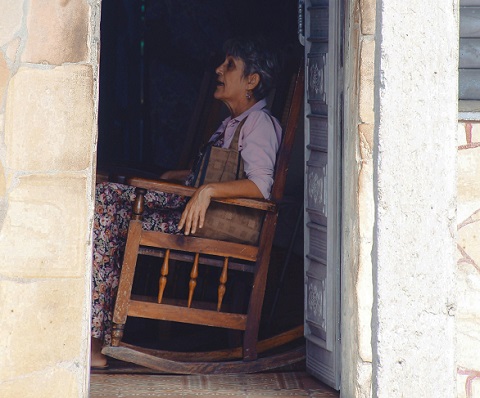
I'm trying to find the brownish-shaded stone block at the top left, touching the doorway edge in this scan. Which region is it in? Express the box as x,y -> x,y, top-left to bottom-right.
22,0 -> 89,65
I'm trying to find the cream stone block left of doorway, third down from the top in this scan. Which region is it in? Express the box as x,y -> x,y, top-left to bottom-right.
0,175 -> 90,278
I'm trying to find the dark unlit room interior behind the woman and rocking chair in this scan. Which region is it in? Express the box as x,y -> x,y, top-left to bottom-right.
97,0 -> 304,350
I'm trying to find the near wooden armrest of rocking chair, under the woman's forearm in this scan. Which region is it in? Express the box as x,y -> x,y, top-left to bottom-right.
127,177 -> 277,212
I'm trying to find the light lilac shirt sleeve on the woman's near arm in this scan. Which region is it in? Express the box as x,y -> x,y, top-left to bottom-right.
238,111 -> 282,199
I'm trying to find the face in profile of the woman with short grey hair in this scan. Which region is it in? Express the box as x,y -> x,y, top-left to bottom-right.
214,55 -> 253,109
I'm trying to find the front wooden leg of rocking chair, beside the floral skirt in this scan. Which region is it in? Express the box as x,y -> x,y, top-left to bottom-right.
112,220 -> 142,347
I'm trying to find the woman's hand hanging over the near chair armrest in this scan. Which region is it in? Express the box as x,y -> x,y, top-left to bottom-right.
178,184 -> 213,235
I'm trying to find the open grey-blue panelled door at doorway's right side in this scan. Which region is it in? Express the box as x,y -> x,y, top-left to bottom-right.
300,0 -> 343,389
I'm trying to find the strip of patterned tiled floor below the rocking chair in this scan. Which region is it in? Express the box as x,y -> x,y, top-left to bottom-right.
90,372 -> 339,398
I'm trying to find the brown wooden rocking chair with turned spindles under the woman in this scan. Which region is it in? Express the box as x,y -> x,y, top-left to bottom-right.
102,61 -> 304,374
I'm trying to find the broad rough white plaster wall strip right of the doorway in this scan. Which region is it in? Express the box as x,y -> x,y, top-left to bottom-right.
372,0 -> 459,398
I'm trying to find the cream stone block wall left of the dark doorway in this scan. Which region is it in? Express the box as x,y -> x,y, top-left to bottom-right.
0,0 -> 100,398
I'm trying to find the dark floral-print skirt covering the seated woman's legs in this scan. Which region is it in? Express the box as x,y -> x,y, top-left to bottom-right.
92,182 -> 186,345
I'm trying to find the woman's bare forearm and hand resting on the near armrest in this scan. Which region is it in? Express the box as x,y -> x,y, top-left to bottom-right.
178,179 -> 263,235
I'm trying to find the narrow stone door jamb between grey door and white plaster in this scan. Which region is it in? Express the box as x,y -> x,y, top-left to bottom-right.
341,0 -> 376,398
